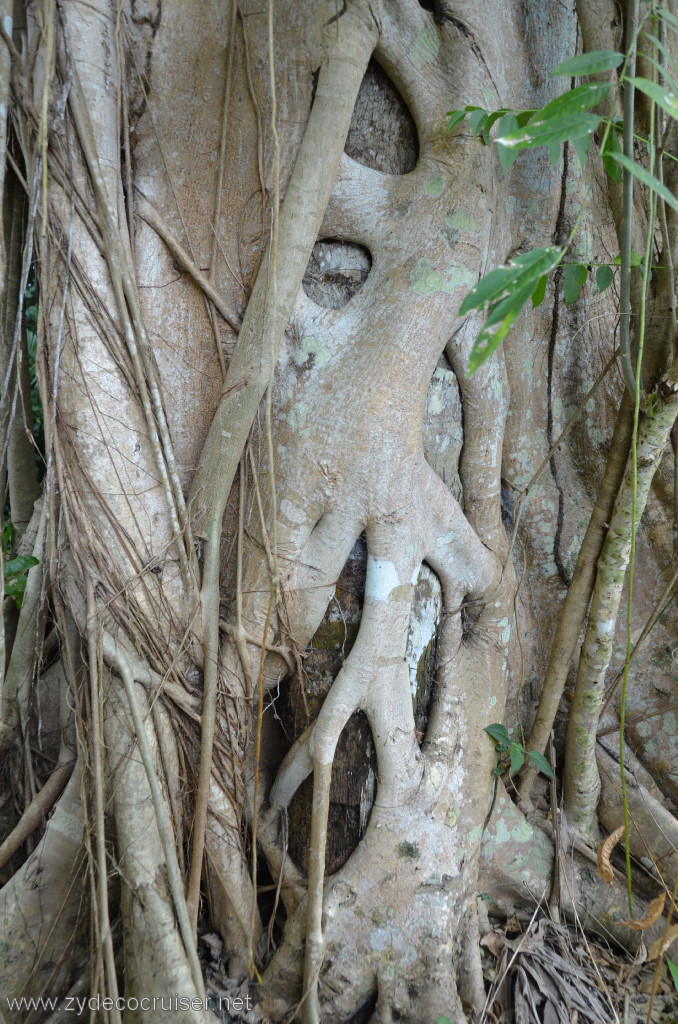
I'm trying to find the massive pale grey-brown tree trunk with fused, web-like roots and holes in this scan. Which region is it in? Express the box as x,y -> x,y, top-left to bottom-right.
0,0 -> 678,1024
